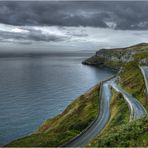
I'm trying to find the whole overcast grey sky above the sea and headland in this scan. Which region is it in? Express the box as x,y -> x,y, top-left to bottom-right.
0,1 -> 148,52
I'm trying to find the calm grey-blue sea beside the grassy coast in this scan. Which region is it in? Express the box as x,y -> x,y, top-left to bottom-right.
0,56 -> 112,146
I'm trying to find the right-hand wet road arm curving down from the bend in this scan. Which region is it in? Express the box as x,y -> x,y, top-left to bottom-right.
111,80 -> 147,120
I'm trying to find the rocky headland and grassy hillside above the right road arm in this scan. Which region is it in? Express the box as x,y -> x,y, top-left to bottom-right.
83,43 -> 148,109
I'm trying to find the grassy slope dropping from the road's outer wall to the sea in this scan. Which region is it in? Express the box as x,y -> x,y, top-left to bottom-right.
6,85 -> 100,147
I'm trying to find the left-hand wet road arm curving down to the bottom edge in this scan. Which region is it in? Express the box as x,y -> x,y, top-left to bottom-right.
64,81 -> 111,147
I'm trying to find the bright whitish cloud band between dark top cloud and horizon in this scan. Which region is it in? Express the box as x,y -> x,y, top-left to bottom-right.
0,24 -> 148,50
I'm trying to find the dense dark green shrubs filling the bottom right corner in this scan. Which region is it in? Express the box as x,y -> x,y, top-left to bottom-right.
88,116 -> 148,147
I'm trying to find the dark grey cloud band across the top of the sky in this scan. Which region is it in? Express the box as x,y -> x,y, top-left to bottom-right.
0,1 -> 148,30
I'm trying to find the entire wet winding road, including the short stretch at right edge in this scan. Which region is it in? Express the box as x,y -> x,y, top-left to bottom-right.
62,66 -> 148,147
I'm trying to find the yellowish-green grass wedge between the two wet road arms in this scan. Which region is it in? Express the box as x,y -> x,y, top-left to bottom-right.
87,90 -> 130,147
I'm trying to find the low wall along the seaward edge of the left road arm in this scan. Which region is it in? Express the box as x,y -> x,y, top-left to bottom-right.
60,76 -> 115,147
